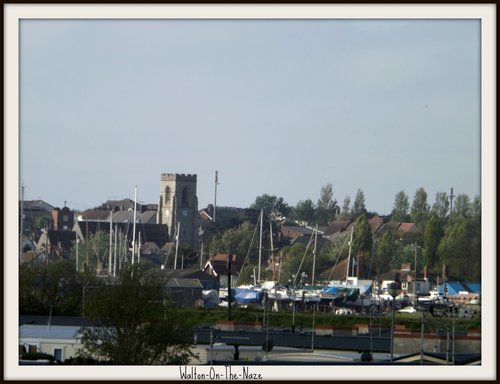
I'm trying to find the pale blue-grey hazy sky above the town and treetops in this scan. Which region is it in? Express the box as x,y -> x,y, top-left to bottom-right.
20,19 -> 481,214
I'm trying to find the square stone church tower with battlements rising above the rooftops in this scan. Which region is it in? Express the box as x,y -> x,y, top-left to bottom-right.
157,173 -> 198,250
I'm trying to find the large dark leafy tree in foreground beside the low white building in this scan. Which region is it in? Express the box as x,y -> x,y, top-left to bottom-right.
80,264 -> 193,365
